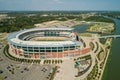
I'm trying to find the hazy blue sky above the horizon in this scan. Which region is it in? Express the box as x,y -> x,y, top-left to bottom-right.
0,0 -> 120,11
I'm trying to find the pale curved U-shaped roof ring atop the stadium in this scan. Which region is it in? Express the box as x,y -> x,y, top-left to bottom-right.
8,28 -> 82,47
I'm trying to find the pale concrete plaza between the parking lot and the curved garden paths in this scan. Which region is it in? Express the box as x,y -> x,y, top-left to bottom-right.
54,59 -> 78,80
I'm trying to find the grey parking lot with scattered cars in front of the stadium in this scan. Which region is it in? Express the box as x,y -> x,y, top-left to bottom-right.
0,44 -> 54,80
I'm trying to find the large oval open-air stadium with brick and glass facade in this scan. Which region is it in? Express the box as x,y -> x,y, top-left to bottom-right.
8,28 -> 89,59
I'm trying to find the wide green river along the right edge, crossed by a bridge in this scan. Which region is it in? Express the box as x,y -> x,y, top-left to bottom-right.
100,16 -> 120,80
